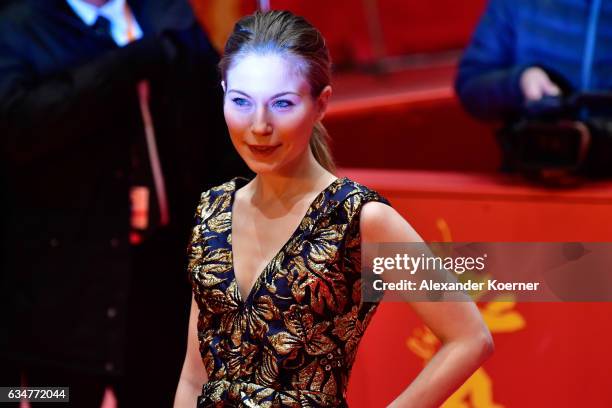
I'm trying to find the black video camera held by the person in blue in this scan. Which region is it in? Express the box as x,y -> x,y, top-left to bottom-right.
498,92 -> 612,185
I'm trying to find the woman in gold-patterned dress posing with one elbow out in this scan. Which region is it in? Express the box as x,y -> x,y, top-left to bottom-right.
175,11 -> 492,407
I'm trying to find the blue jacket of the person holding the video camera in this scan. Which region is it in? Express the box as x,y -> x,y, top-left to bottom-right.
455,0 -> 612,119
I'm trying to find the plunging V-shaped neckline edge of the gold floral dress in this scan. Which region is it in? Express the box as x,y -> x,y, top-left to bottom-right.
226,177 -> 346,304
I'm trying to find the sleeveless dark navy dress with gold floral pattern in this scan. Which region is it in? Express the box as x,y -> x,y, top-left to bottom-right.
188,178 -> 388,408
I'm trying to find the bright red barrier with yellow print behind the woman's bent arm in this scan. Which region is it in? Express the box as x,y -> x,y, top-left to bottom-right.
342,169 -> 612,408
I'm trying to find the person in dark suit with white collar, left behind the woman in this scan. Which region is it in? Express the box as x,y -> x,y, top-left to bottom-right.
0,0 -> 245,407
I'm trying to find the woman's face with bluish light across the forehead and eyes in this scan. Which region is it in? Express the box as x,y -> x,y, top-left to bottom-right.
223,53 -> 331,174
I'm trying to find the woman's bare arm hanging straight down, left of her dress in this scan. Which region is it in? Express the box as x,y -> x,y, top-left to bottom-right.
174,297 -> 208,408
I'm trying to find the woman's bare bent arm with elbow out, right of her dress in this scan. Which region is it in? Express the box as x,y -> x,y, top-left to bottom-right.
360,202 -> 493,407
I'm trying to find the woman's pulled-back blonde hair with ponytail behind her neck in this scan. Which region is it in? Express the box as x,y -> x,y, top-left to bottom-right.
219,10 -> 336,173
